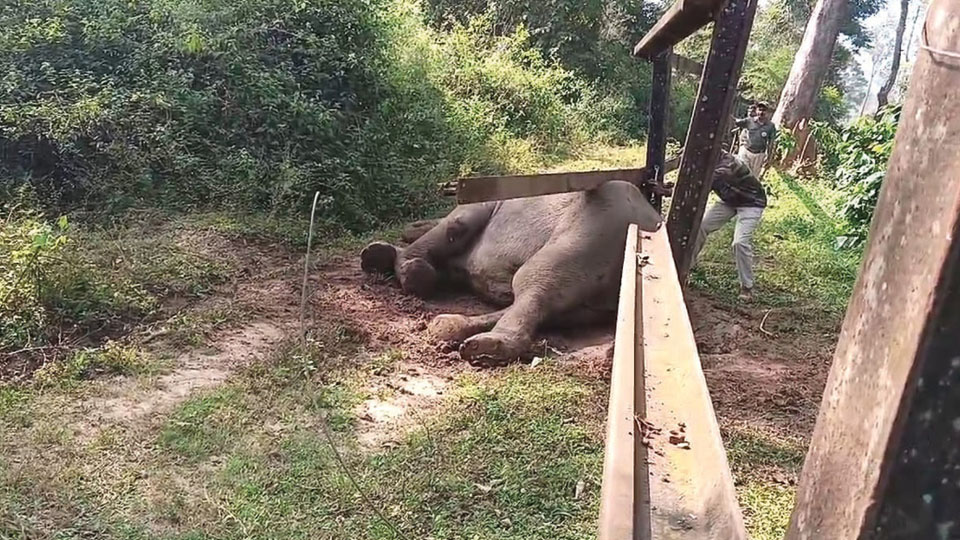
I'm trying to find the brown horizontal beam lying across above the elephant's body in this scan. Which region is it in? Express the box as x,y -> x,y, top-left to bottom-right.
457,168 -> 651,204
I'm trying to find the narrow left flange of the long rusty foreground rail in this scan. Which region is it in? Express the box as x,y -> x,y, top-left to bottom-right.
597,221 -> 650,540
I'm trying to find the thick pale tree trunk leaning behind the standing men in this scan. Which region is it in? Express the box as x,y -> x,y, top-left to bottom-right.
773,0 -> 847,129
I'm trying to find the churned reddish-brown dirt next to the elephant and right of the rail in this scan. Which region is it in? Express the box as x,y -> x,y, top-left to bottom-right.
313,242 -> 836,448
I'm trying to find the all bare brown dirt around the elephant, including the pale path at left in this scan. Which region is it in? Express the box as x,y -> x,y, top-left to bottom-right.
9,224 -> 836,460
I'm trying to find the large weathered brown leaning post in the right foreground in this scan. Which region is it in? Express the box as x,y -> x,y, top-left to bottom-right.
787,0 -> 960,540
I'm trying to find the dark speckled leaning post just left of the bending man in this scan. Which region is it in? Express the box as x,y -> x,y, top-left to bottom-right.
667,0 -> 757,283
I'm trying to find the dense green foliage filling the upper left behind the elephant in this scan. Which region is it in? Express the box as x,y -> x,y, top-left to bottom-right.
0,0 -> 609,229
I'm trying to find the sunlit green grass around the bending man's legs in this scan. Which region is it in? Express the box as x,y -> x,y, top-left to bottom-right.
691,171 -> 861,319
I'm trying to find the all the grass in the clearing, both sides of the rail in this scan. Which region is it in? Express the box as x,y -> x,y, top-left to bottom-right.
0,148 -> 856,539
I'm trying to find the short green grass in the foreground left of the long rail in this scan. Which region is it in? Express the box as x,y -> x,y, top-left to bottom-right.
0,322 -> 604,539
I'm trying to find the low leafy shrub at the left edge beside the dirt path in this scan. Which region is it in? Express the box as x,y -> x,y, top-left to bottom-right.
0,200 -> 228,353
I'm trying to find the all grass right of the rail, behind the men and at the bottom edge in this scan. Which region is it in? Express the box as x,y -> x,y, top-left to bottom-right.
691,167 -> 860,540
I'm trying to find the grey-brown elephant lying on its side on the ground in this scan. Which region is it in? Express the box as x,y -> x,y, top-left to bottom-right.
360,181 -> 661,364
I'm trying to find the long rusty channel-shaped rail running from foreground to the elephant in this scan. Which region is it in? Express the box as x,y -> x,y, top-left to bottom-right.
598,225 -> 747,540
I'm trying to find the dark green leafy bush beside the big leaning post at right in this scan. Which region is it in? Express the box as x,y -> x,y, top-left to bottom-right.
815,106 -> 900,246
